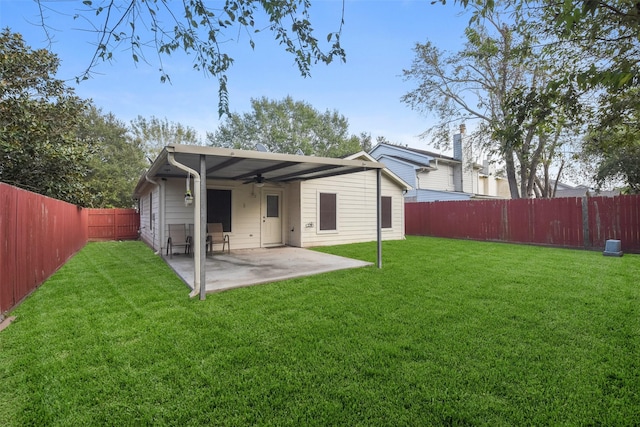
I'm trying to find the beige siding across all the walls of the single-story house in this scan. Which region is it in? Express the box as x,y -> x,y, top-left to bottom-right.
140,171 -> 404,255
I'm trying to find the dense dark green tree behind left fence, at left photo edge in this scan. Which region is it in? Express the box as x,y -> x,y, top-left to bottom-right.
0,29 -> 92,205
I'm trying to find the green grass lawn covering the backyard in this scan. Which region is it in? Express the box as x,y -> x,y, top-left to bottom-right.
0,237 -> 640,426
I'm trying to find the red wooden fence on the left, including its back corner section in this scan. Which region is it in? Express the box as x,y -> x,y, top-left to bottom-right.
0,183 -> 140,315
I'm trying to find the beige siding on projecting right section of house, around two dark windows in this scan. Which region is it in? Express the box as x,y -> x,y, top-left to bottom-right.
301,171 -> 404,247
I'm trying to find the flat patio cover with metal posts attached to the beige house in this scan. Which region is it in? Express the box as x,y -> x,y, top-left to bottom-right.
134,144 -> 384,299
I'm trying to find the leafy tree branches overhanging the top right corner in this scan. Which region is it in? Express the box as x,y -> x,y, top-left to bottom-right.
440,0 -> 640,89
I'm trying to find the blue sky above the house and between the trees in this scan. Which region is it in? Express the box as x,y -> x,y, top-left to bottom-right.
0,0 -> 469,148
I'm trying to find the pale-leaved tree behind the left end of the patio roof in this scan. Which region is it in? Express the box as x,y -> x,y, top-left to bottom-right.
131,116 -> 201,161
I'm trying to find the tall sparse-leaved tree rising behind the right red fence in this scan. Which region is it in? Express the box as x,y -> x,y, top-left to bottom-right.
402,11 -> 579,199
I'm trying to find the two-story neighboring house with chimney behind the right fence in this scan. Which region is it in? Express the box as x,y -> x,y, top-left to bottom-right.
370,134 -> 509,202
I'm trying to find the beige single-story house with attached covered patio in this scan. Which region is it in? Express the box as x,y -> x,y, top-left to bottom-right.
134,145 -> 410,254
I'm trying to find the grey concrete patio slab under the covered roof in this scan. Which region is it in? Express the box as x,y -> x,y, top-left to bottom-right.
164,247 -> 373,293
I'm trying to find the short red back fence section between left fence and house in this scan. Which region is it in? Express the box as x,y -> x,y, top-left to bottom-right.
89,209 -> 140,241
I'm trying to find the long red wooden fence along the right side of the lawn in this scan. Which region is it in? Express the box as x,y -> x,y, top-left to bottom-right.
405,195 -> 640,253
